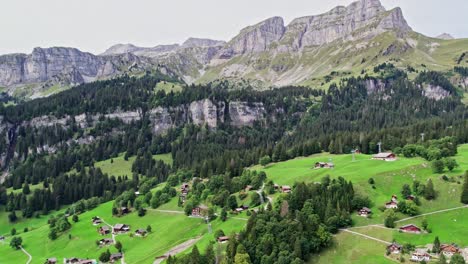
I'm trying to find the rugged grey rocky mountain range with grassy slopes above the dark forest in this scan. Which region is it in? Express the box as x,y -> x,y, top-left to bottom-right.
0,0 -> 468,98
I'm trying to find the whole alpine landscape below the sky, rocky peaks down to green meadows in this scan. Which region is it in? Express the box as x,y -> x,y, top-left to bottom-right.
0,0 -> 468,264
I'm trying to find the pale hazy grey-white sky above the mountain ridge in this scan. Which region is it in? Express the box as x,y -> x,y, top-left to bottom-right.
0,0 -> 468,54
